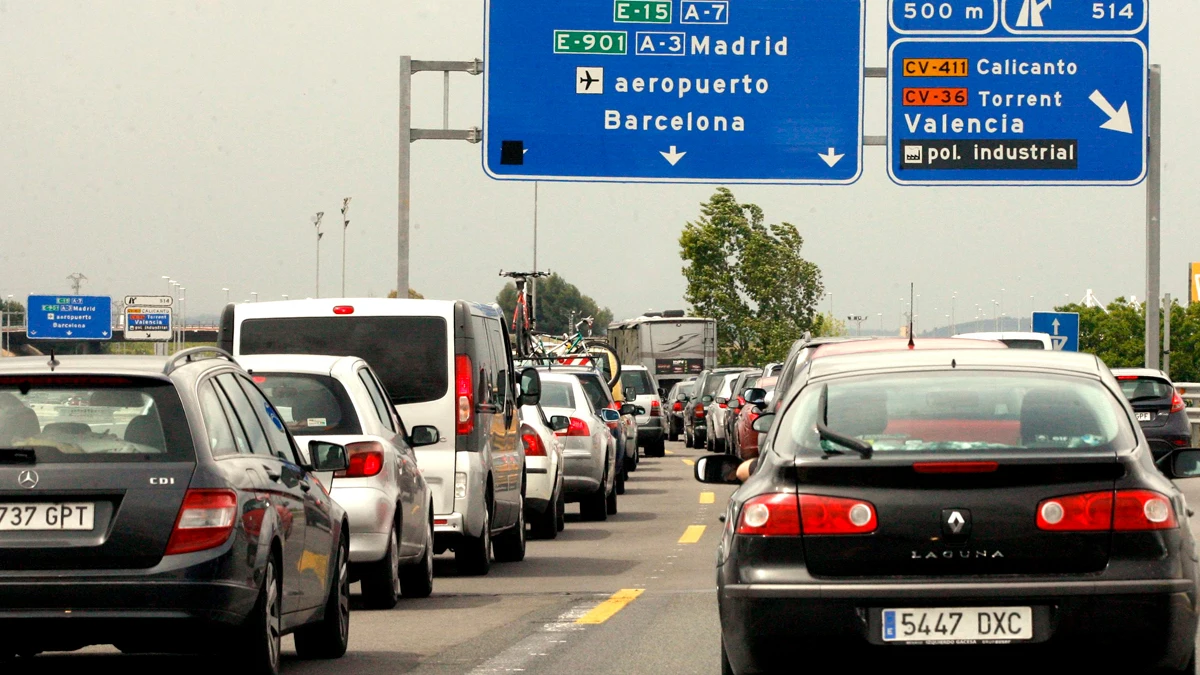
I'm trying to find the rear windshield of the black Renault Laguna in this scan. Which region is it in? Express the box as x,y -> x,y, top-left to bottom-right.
778,371 -> 1135,454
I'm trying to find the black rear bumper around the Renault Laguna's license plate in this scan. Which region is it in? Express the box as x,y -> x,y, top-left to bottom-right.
719,579 -> 1196,673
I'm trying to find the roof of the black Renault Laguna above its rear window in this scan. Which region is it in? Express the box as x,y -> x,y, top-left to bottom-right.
809,347 -> 1104,377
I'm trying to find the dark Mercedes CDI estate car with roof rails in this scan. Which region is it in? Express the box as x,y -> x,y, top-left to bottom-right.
0,348 -> 349,675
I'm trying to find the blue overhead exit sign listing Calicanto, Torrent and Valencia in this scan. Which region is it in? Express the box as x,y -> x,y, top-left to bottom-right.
888,0 -> 1148,185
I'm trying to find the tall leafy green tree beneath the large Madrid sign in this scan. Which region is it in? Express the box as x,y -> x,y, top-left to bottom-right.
679,187 -> 825,364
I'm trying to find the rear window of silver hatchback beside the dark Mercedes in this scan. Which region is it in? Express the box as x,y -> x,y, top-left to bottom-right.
254,372 -> 362,436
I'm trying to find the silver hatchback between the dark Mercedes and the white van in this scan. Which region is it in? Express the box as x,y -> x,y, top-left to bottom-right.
238,354 -> 438,609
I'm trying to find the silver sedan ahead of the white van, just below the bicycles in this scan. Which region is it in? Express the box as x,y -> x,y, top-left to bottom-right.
541,368 -> 617,520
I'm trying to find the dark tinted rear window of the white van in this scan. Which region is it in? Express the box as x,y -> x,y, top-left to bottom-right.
238,316 -> 450,405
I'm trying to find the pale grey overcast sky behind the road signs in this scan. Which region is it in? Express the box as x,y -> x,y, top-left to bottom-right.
0,0 -> 1200,328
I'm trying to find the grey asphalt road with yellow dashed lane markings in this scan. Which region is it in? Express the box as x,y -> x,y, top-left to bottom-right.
6,443 -> 733,675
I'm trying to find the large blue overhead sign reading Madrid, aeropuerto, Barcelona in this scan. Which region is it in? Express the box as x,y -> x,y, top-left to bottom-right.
484,0 -> 865,184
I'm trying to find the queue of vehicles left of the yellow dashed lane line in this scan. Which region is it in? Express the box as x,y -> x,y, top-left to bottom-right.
0,299 -> 666,675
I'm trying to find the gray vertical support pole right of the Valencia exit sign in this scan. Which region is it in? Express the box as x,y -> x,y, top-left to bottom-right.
1146,65 -> 1163,370
